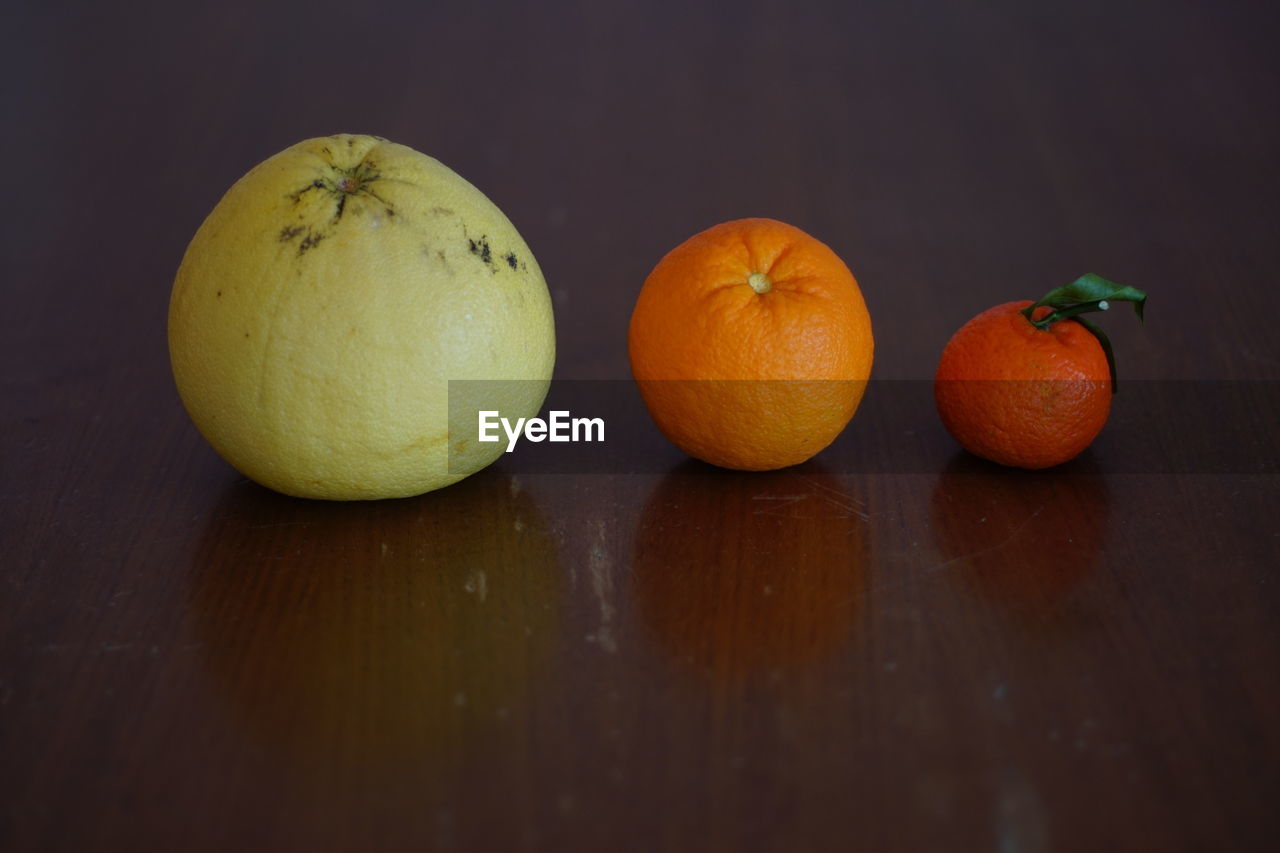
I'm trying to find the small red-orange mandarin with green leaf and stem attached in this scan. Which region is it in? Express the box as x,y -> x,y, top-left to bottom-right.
933,274 -> 1147,469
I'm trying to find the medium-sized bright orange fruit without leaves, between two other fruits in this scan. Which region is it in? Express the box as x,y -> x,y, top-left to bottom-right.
627,219 -> 874,470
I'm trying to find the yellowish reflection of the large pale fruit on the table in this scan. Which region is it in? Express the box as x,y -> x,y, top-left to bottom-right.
191,471 -> 561,771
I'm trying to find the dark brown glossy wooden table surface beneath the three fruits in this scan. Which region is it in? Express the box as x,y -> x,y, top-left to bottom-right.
0,0 -> 1280,853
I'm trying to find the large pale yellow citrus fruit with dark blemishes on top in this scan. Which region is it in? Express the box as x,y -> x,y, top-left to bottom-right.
169,133 -> 556,500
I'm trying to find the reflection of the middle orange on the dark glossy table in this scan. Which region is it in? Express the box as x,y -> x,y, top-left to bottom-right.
631,461 -> 869,683
